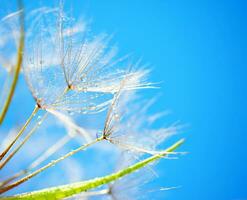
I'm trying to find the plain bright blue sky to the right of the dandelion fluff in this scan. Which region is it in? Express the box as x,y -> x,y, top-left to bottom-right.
0,0 -> 247,200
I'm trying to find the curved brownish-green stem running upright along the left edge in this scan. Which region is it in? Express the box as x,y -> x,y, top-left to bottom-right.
0,0 -> 25,125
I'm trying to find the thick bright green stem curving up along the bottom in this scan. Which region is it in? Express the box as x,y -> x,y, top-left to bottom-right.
1,139 -> 184,200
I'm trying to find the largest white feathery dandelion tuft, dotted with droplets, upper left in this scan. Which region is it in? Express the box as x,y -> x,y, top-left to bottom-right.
24,8 -> 154,114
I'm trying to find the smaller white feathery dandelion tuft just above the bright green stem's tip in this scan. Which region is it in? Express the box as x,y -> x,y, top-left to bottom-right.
103,92 -> 179,155
